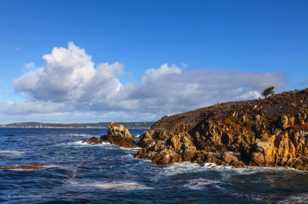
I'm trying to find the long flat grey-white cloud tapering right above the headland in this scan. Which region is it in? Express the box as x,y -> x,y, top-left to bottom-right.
124,64 -> 282,115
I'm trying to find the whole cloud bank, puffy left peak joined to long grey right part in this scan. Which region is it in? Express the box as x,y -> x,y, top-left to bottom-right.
6,42 -> 283,120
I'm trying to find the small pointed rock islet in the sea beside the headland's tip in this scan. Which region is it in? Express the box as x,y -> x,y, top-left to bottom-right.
82,123 -> 136,148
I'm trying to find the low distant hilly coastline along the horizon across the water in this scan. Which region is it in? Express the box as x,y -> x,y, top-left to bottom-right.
0,122 -> 153,128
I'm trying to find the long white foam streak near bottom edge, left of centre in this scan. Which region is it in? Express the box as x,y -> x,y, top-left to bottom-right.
71,181 -> 152,191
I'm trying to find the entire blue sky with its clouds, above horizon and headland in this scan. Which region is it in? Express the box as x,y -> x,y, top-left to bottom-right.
0,0 -> 308,124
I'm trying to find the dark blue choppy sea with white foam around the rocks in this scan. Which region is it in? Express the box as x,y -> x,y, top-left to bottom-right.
0,129 -> 308,204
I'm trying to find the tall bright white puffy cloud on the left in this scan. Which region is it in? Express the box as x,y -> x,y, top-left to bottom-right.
14,42 -> 122,102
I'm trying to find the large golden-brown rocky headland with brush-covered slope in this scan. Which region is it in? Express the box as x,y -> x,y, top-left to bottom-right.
136,89 -> 308,171
